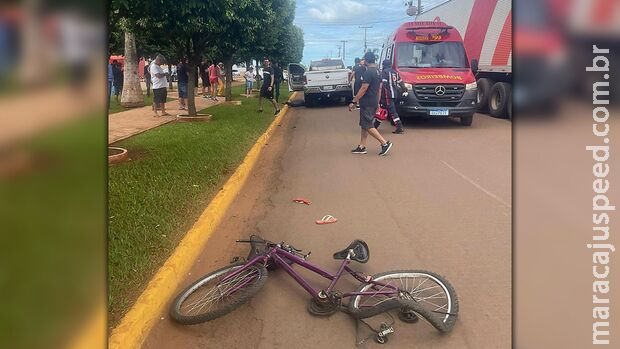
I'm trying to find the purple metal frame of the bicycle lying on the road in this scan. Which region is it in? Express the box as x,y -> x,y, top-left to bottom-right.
220,246 -> 399,299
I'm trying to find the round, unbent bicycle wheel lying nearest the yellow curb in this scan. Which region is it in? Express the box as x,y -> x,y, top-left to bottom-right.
170,263 -> 267,325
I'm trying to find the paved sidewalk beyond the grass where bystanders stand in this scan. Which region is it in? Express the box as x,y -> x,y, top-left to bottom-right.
108,91 -> 224,144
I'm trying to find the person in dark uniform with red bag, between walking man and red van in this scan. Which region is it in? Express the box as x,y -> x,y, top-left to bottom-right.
374,59 -> 408,134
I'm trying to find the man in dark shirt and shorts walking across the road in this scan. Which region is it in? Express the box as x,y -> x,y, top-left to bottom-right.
349,52 -> 392,156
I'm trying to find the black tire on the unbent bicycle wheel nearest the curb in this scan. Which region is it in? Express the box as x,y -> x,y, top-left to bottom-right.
169,262 -> 267,325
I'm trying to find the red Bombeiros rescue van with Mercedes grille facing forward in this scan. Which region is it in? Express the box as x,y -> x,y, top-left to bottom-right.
381,21 -> 478,126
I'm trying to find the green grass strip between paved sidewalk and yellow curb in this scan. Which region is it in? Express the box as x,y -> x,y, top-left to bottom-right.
108,85 -> 288,325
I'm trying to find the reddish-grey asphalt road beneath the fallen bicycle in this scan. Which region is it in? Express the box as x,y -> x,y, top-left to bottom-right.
144,96 -> 511,349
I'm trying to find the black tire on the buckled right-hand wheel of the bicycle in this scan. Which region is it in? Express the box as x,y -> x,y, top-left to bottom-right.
348,270 -> 459,333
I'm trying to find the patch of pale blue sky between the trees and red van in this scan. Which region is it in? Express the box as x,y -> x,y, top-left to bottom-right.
295,0 -> 446,66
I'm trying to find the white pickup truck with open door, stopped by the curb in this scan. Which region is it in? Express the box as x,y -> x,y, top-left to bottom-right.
288,58 -> 353,107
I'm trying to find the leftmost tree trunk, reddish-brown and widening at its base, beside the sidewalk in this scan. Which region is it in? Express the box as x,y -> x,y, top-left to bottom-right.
121,31 -> 144,108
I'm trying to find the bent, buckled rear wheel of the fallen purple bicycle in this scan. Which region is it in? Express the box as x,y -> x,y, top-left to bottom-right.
349,270 -> 459,332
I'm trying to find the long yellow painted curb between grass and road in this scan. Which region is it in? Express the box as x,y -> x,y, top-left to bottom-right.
108,92 -> 297,349
